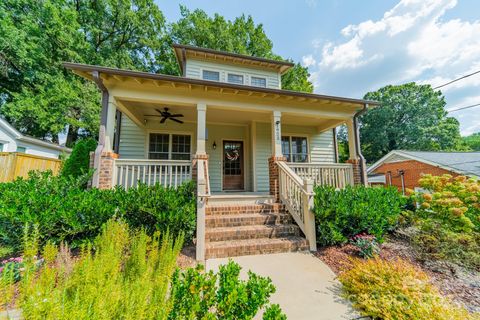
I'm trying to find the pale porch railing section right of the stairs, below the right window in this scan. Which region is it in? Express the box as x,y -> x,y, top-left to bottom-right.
288,163 -> 354,189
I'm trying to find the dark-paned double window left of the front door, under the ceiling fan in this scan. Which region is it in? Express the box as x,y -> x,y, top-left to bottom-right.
148,133 -> 190,160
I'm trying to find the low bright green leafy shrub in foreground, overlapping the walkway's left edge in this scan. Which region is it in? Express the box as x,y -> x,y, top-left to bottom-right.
169,261 -> 283,320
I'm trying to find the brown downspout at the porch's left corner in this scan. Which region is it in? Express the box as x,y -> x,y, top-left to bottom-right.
92,71 -> 109,188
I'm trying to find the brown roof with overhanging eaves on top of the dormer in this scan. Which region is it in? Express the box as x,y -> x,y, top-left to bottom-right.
172,44 -> 295,74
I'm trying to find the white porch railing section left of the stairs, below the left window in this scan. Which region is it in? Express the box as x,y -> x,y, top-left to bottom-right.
113,159 -> 192,189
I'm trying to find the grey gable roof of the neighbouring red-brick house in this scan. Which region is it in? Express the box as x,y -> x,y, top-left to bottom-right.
367,150 -> 480,177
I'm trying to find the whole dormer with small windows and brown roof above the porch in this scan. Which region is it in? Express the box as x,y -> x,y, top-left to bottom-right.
173,44 -> 293,89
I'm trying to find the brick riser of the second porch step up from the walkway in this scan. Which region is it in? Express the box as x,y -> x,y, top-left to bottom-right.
205,226 -> 300,242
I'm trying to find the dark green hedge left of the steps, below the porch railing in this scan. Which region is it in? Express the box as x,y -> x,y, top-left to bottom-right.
0,172 -> 196,251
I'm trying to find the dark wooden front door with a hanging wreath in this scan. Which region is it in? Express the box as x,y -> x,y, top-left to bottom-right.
223,141 -> 244,190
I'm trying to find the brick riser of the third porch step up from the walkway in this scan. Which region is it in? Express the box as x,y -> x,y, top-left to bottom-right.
205,214 -> 292,228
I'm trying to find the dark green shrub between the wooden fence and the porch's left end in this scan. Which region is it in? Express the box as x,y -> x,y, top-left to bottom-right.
61,138 -> 97,177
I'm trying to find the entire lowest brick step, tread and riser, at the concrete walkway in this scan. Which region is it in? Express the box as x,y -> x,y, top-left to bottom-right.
205,236 -> 308,258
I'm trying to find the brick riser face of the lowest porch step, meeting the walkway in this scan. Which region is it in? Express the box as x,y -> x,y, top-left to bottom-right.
205,241 -> 308,259
